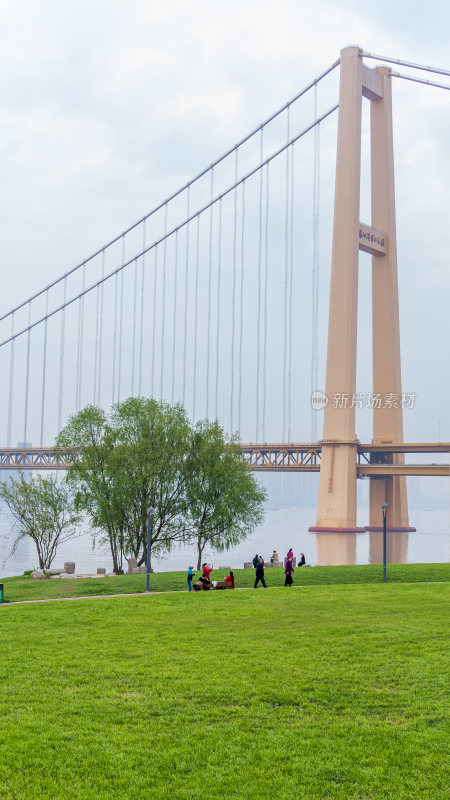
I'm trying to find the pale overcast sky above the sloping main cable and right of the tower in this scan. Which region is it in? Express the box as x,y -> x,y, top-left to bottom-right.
0,0 -> 450,450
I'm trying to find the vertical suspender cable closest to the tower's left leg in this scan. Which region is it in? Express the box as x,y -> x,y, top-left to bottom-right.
311,84 -> 320,442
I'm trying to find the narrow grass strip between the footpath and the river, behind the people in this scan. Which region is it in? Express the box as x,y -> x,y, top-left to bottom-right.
3,564 -> 450,603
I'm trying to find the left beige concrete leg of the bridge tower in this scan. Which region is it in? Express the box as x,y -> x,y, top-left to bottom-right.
310,47 -> 362,532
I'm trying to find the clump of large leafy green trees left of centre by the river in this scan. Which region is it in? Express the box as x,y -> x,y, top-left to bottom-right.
56,398 -> 265,572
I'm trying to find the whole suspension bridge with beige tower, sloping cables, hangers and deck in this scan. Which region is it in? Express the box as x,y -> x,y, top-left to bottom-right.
0,47 -> 450,532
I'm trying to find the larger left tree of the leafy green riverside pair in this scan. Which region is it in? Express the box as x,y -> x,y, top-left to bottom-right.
57,397 -> 191,572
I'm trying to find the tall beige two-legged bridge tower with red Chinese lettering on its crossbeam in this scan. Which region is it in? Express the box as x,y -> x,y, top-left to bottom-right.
310,47 -> 414,533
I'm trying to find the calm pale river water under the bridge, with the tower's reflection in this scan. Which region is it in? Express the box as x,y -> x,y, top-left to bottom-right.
0,500 -> 450,577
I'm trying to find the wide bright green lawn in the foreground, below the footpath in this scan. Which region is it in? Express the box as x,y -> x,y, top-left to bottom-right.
0,580 -> 449,800
